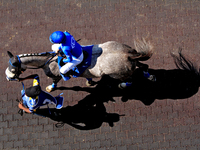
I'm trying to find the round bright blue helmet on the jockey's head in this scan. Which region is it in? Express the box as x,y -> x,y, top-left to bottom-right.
49,31 -> 65,43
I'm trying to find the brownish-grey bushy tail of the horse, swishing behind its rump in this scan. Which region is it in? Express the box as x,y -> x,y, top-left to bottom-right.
129,38 -> 153,61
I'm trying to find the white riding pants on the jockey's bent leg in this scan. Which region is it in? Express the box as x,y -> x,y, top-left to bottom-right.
60,53 -> 83,74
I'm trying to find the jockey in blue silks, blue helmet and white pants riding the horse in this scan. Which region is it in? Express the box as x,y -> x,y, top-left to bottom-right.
49,31 -> 83,76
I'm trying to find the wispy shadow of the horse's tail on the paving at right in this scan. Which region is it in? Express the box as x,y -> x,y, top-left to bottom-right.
171,48 -> 200,79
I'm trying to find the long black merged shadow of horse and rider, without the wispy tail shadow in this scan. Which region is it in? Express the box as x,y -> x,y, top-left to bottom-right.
34,64 -> 200,130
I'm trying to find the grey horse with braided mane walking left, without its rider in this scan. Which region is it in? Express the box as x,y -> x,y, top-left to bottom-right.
5,39 -> 156,92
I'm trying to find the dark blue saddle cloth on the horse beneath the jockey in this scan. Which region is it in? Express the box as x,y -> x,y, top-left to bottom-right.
58,45 -> 93,81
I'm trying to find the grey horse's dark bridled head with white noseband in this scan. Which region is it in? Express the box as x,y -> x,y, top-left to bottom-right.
5,51 -> 25,81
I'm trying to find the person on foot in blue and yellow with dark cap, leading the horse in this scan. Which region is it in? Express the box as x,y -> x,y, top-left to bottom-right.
18,74 -> 64,113
